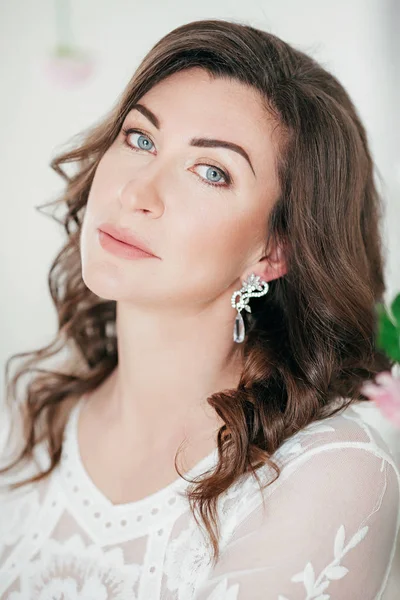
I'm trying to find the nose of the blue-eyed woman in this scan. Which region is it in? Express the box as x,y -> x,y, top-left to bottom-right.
119,161 -> 164,219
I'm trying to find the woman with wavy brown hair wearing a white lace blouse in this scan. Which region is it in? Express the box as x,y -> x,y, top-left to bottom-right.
0,20 -> 400,600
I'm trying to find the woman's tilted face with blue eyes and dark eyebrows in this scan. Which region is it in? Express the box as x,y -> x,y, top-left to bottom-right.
81,68 -> 279,309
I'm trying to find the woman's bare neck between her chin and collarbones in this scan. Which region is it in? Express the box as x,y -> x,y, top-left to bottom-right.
99,298 -> 242,444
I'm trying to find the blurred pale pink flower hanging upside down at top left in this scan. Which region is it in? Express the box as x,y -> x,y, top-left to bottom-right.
45,0 -> 94,88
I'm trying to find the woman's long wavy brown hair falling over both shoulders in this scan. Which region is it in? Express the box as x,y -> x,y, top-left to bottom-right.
2,19 -> 392,563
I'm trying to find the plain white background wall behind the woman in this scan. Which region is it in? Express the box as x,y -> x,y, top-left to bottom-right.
0,0 -> 400,596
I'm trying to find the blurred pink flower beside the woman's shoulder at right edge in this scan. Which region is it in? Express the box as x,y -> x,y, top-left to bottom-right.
361,371 -> 400,427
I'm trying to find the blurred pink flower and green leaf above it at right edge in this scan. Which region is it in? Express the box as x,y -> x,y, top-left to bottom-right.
361,294 -> 400,428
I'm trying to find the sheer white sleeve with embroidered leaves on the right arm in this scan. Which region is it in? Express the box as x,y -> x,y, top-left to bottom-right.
196,442 -> 400,600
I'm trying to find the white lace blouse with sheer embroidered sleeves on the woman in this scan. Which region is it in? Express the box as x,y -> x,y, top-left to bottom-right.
0,397 -> 400,600
